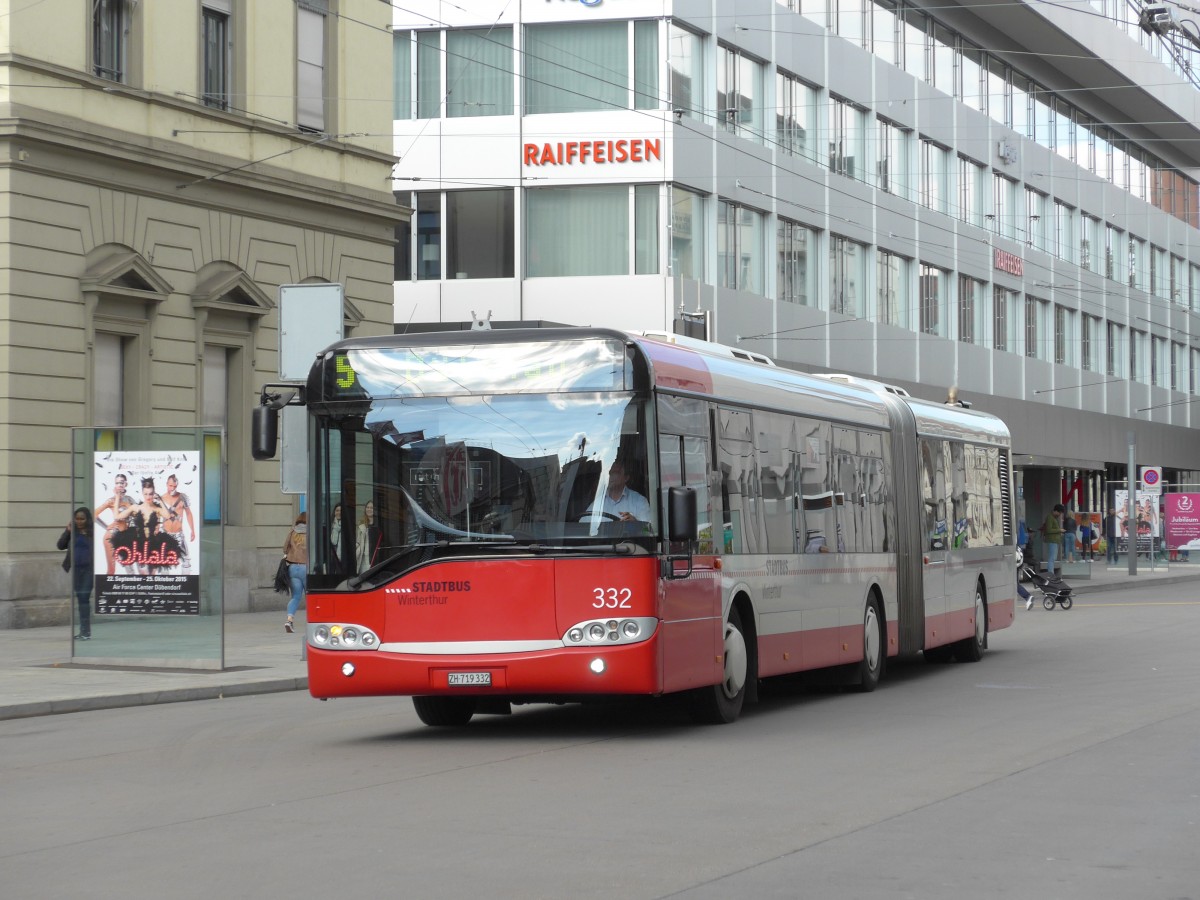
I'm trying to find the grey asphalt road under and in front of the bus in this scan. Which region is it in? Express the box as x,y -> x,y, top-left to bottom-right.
0,584 -> 1200,900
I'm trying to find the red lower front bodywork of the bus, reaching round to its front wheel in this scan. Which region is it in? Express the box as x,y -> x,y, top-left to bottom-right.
308,556 -> 722,697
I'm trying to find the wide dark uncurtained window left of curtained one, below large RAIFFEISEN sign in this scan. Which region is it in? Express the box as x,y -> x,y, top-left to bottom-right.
446,194 -> 516,278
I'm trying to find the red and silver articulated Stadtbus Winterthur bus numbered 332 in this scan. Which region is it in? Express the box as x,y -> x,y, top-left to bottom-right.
254,328 -> 1016,725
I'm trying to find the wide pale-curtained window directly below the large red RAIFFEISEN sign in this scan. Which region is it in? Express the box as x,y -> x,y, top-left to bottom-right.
526,185 -> 659,278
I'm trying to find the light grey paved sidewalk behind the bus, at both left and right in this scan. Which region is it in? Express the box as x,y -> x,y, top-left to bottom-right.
0,560 -> 1200,720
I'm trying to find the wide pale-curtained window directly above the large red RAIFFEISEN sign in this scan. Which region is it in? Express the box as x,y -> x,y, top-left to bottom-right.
523,20 -> 657,115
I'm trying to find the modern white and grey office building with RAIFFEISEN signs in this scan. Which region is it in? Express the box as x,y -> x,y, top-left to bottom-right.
394,0 -> 1200,535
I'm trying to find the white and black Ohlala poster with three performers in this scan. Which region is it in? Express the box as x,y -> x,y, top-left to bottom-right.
92,450 -> 200,616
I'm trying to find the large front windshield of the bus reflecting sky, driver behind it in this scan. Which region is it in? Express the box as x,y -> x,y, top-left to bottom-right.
308,392 -> 659,587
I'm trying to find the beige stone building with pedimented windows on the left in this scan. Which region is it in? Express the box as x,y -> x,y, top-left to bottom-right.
0,0 -> 404,628
